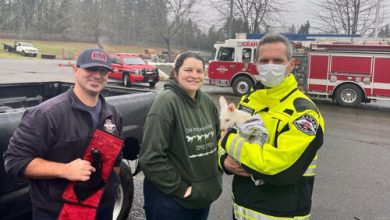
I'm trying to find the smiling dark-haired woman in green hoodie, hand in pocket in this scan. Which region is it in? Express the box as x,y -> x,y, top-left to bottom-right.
140,52 -> 222,220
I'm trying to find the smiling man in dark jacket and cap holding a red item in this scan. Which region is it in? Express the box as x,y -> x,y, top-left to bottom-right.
4,49 -> 122,219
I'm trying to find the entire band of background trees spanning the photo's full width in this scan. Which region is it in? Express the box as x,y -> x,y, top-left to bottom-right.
0,0 -> 389,55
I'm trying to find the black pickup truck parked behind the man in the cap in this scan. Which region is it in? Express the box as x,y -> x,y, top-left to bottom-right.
0,82 -> 156,220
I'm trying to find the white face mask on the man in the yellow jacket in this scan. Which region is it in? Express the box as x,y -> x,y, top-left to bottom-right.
256,63 -> 287,88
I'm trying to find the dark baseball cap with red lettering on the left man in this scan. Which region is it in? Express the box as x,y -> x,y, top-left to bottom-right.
76,48 -> 112,72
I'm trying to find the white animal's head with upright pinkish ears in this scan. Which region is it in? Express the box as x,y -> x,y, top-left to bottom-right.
219,96 -> 251,131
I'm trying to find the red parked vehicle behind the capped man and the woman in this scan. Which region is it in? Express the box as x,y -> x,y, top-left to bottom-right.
109,53 -> 159,88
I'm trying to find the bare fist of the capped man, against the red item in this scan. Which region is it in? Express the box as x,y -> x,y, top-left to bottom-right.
63,158 -> 96,181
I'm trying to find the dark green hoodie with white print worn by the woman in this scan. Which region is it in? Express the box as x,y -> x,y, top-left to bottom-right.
139,80 -> 222,209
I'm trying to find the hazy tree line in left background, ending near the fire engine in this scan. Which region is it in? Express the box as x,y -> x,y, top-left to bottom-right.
0,0 -> 225,53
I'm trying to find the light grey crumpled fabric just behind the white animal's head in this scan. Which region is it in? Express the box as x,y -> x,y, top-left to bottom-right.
238,114 -> 268,146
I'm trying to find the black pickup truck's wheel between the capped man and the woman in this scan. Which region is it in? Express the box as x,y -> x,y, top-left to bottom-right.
112,162 -> 134,220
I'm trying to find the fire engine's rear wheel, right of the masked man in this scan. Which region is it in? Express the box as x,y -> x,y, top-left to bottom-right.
335,84 -> 363,107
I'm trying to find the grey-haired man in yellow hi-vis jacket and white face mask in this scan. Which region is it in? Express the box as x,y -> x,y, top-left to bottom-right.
219,34 -> 324,220
